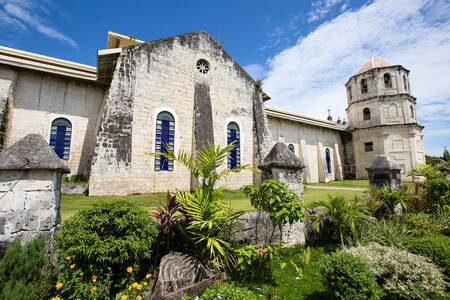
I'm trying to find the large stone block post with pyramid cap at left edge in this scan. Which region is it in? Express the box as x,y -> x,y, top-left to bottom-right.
0,134 -> 70,258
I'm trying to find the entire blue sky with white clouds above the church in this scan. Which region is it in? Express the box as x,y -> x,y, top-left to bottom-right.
0,0 -> 450,155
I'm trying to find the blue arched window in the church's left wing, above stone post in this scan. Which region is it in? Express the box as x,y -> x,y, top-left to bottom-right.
50,118 -> 72,160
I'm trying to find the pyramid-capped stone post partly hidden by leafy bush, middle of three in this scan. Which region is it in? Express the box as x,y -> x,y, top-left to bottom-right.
259,142 -> 306,202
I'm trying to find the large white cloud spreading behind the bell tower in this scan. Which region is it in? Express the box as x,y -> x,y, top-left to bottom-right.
264,0 -> 450,155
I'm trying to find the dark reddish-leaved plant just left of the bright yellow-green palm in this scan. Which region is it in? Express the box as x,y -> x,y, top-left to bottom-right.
148,191 -> 184,256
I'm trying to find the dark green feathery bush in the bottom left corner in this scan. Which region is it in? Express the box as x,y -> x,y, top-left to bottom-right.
0,235 -> 55,300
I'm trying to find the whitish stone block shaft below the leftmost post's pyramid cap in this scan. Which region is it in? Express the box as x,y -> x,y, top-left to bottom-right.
0,170 -> 61,257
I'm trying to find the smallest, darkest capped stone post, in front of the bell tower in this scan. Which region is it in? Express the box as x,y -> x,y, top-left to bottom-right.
366,155 -> 402,192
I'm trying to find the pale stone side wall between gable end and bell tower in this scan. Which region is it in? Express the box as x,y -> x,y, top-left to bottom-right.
268,116 -> 343,183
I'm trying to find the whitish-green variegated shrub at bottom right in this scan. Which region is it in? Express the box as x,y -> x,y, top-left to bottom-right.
348,243 -> 446,299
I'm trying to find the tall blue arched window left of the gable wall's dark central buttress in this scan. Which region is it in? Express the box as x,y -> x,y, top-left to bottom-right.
155,111 -> 175,171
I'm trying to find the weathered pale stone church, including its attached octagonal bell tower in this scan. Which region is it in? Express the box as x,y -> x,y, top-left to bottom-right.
0,31 -> 425,195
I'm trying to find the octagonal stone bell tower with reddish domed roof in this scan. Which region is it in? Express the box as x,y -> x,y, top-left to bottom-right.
345,58 -> 425,180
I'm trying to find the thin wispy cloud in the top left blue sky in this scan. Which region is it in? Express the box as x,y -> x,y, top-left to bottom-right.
0,0 -> 78,49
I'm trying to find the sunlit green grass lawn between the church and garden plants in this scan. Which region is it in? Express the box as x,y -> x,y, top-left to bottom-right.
61,186 -> 361,221
